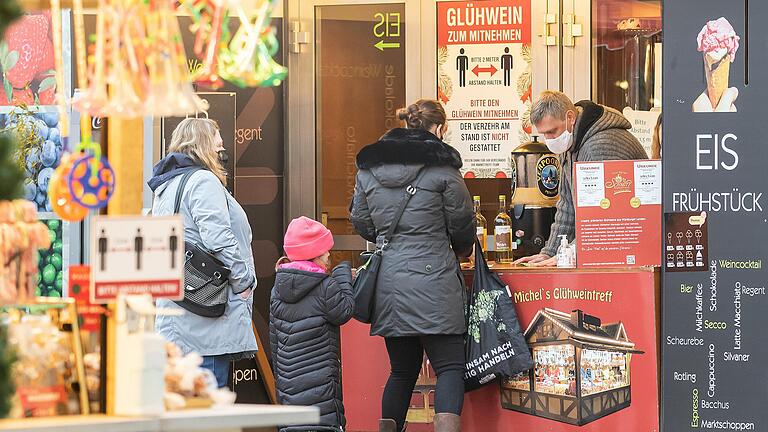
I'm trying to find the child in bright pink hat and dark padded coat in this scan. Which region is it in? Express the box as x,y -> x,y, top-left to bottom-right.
269,216 -> 355,428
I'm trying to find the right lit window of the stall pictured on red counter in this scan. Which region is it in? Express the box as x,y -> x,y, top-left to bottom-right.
580,349 -> 629,396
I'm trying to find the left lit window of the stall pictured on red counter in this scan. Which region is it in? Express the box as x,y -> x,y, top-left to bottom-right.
533,344 -> 577,397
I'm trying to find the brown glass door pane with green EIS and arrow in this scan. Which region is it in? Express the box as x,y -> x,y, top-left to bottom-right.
315,4 -> 406,236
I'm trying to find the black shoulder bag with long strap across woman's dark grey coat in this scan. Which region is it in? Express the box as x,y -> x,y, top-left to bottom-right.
352,168 -> 424,324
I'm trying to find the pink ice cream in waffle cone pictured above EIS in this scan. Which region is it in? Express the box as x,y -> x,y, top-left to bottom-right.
696,17 -> 739,109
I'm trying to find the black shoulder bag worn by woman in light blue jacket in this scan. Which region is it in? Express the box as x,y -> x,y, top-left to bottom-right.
173,169 -> 230,318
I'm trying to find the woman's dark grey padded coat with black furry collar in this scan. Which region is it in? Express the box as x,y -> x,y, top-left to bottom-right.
350,129 -> 475,337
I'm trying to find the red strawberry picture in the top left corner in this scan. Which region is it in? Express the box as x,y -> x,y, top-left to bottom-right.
0,13 -> 56,105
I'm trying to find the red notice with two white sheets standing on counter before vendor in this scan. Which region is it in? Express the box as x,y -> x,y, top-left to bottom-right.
574,161 -> 661,268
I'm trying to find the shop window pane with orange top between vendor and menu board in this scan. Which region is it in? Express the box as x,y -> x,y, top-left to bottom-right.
592,0 -> 662,111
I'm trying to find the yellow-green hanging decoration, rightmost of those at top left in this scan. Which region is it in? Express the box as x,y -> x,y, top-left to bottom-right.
219,0 -> 288,87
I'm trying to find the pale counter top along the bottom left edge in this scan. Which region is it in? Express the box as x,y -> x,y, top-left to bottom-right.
0,405 -> 320,432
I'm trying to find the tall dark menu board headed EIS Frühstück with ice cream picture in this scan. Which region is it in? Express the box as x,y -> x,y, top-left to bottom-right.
662,0 -> 768,432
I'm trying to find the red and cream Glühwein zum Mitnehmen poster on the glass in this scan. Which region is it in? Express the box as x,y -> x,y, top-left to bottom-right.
437,0 -> 531,178
